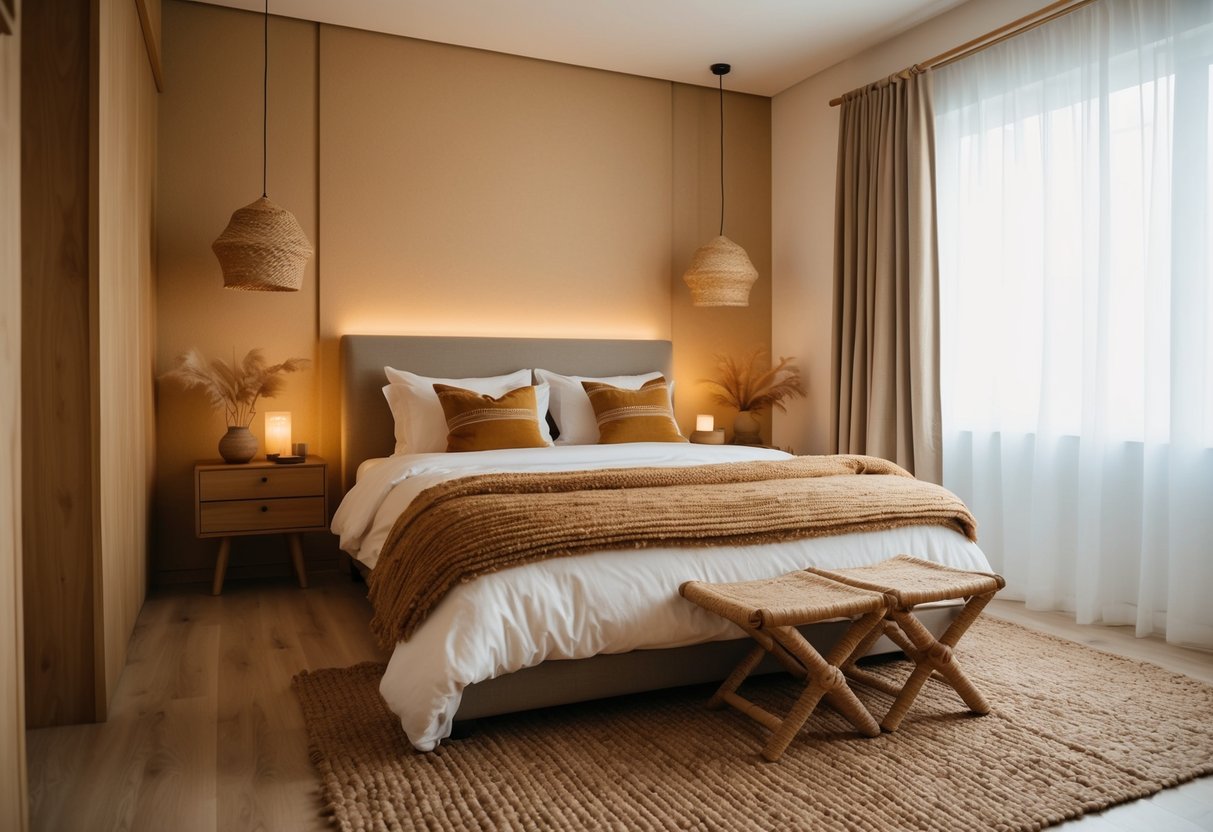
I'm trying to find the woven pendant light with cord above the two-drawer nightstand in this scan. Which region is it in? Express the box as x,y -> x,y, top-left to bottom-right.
211,0 -> 314,292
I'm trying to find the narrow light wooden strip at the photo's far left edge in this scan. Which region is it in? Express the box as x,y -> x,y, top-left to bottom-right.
0,5 -> 28,832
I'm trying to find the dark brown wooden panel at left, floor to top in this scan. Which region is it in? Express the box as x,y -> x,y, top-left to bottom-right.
21,0 -> 96,728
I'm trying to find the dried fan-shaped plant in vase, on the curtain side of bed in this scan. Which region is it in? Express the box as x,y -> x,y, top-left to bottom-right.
702,347 -> 805,445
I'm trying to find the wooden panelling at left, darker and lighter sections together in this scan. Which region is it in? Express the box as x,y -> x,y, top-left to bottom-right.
22,0 -> 156,728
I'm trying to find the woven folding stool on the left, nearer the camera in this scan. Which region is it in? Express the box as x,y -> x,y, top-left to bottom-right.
678,572 -> 887,763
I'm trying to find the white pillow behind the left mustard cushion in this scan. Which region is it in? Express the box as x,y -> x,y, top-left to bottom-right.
383,367 -> 552,454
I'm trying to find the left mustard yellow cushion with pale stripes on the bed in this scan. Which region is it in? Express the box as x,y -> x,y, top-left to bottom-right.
434,384 -> 547,451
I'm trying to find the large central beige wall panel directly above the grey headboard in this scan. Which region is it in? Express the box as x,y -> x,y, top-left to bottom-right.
320,25 -> 672,338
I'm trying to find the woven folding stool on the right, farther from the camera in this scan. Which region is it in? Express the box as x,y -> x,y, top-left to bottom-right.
809,554 -> 1007,731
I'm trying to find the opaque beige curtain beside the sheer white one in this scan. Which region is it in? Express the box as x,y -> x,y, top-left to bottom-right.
832,72 -> 943,483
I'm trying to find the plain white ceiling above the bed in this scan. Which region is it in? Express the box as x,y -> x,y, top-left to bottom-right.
186,0 -> 964,96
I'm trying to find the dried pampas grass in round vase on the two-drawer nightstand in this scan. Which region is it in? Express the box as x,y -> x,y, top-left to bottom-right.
163,349 -> 308,463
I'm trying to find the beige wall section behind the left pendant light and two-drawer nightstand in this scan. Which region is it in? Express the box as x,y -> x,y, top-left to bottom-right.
153,0 -> 320,580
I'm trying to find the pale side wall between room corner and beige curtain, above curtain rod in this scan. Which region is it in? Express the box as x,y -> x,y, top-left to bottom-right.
771,0 -> 1041,454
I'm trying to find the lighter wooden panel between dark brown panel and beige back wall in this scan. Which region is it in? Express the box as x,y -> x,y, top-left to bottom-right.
92,0 -> 156,716
